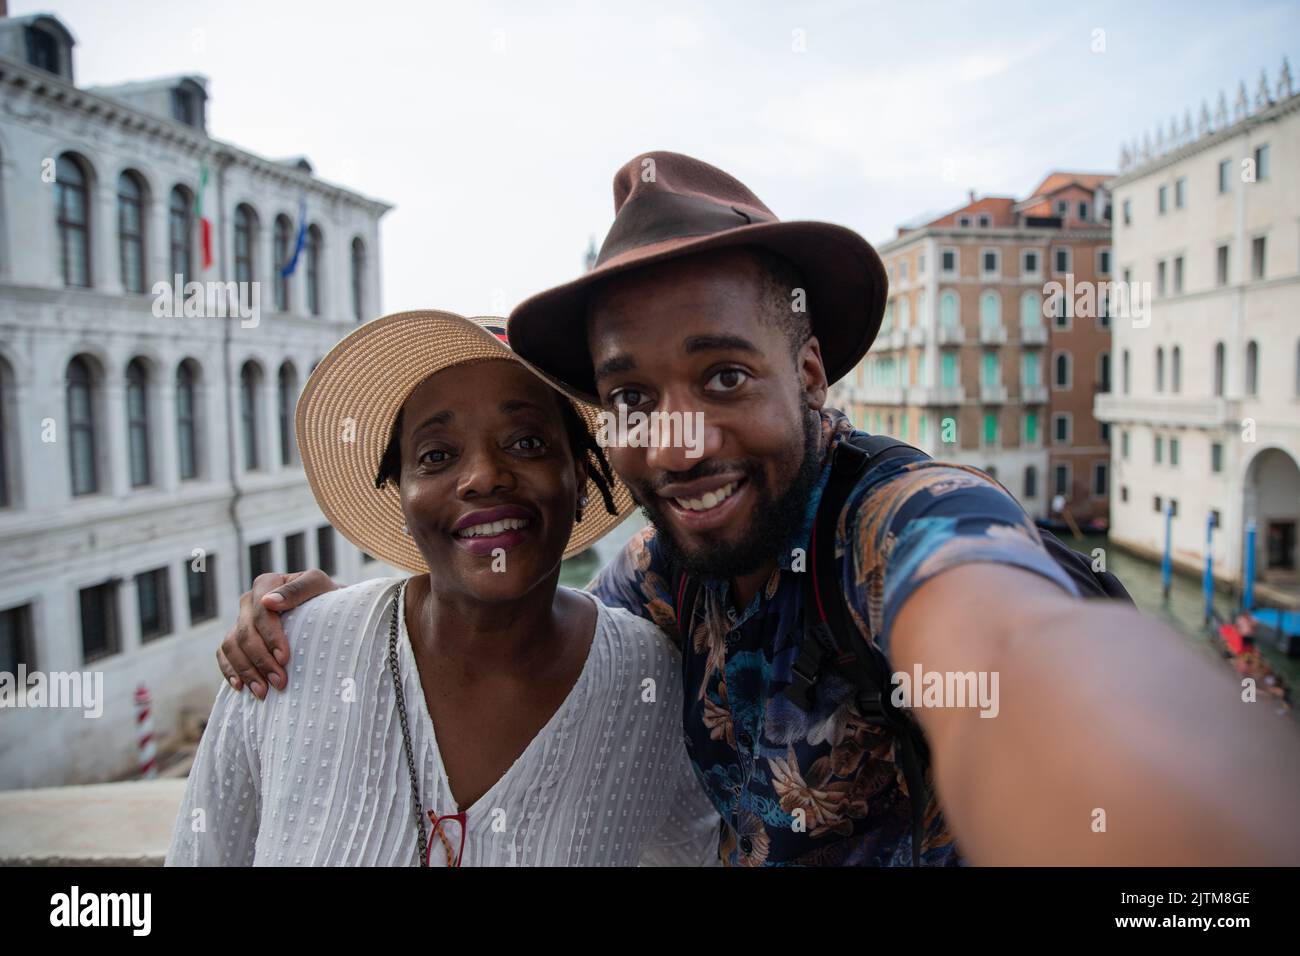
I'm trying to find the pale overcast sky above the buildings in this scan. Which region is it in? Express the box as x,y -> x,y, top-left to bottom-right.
20,0 -> 1300,313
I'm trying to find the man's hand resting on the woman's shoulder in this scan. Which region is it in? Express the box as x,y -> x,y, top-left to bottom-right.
217,567 -> 338,700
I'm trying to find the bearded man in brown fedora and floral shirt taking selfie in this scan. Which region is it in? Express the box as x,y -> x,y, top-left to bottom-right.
218,152 -> 1300,865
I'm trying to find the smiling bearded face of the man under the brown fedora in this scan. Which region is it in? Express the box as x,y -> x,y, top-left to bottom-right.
588,250 -> 826,579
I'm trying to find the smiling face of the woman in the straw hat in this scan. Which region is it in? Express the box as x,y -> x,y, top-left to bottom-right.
399,359 -> 585,601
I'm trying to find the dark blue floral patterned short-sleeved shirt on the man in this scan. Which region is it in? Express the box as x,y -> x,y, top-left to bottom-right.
589,410 -> 1078,866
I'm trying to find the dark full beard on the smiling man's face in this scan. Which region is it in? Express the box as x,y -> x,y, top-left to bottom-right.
629,410 -> 822,581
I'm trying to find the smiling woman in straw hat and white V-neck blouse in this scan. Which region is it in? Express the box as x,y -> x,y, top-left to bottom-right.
166,312 -> 719,866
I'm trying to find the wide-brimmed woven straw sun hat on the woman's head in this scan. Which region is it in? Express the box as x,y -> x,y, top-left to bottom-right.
295,310 -> 634,574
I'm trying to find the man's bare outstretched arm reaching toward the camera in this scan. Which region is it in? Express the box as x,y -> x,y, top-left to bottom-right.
889,563 -> 1300,866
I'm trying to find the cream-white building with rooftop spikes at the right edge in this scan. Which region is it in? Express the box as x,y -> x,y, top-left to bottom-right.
1096,64 -> 1300,602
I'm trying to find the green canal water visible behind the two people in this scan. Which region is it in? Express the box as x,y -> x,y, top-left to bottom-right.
560,522 -> 1300,719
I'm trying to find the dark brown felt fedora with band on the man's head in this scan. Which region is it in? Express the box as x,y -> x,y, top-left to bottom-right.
507,152 -> 889,403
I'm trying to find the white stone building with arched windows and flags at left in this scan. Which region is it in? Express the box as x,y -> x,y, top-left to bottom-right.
0,16 -> 390,788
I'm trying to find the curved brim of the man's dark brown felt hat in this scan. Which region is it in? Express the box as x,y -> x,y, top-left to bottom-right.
508,221 -> 889,403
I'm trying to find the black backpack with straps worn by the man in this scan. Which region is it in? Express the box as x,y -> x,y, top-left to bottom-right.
673,432 -> 1132,866
